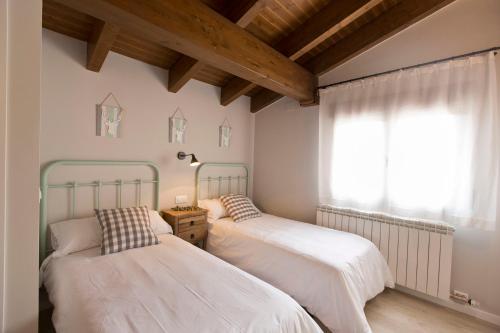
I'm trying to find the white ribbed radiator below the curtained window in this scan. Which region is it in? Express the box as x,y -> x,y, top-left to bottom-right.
316,206 -> 455,299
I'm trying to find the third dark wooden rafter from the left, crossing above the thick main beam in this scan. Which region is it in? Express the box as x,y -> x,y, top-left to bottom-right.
221,0 -> 376,106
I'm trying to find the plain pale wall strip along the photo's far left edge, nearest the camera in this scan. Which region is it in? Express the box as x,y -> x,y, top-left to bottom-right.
0,0 -> 42,333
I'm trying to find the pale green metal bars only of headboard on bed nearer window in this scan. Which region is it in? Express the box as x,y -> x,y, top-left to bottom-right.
194,162 -> 249,201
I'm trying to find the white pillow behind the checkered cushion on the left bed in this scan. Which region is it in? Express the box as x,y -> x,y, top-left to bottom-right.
49,210 -> 173,254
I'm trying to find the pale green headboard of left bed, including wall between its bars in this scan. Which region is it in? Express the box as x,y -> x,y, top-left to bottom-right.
39,160 -> 160,263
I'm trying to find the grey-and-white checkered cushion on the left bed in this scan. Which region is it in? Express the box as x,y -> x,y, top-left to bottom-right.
95,206 -> 160,255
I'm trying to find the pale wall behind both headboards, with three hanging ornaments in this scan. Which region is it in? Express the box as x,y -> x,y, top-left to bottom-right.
40,30 -> 254,208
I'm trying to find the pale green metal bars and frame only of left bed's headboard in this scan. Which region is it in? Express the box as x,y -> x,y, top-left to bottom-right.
39,160 -> 160,263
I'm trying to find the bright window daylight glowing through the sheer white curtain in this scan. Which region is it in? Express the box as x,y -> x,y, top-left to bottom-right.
330,108 -> 471,212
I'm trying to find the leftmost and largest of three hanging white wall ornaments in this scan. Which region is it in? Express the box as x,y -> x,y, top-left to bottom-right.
96,93 -> 124,138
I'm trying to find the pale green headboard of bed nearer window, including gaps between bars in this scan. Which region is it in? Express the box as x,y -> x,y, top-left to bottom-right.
194,163 -> 249,201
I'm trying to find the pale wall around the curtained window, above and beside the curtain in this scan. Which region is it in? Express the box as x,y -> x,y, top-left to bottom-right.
254,0 -> 500,319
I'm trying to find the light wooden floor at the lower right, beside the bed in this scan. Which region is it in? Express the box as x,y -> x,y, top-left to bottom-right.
365,289 -> 500,333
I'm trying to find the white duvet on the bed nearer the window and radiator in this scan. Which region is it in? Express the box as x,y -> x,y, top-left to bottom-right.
207,214 -> 394,333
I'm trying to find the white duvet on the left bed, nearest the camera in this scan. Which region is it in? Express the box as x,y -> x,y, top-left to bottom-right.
43,235 -> 321,333
